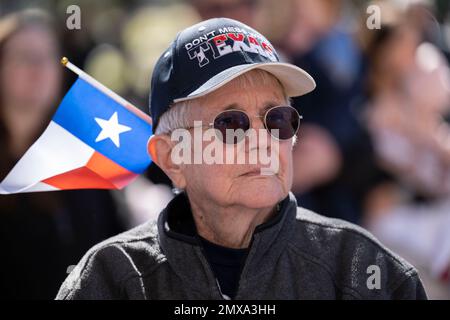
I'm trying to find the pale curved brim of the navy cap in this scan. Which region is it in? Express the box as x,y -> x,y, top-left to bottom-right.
174,62 -> 316,102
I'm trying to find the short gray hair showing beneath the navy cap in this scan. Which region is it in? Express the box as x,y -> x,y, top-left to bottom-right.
155,69 -> 290,134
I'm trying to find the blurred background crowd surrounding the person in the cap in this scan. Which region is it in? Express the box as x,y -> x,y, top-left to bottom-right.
0,0 -> 450,299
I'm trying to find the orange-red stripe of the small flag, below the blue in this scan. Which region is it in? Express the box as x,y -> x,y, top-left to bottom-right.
42,152 -> 137,190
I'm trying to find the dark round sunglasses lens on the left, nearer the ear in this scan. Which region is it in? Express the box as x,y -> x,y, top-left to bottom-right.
214,110 -> 250,144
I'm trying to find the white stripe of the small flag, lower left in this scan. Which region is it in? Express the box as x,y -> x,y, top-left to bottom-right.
0,121 -> 95,194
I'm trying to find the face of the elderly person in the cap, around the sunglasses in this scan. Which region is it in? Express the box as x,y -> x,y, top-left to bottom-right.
182,75 -> 292,209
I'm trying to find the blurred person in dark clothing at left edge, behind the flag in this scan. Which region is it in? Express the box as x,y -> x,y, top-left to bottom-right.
0,11 -> 123,299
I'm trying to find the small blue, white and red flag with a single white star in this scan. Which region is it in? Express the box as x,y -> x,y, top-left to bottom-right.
0,77 -> 152,194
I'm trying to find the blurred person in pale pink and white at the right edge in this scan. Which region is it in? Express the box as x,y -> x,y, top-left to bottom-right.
363,3 -> 450,299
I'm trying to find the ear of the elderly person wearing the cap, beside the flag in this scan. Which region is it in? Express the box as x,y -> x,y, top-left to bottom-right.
147,135 -> 186,189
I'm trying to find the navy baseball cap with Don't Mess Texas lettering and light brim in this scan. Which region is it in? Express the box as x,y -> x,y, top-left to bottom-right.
150,18 -> 316,128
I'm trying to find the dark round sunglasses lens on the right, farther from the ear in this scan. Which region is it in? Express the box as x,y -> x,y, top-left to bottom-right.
266,106 -> 300,140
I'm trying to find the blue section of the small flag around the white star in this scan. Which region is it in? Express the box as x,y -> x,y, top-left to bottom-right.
53,78 -> 152,173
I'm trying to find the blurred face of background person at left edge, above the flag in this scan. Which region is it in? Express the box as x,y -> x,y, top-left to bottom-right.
0,26 -> 61,112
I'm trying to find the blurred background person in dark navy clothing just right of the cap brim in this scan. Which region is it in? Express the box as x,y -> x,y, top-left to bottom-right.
257,0 -> 366,223
